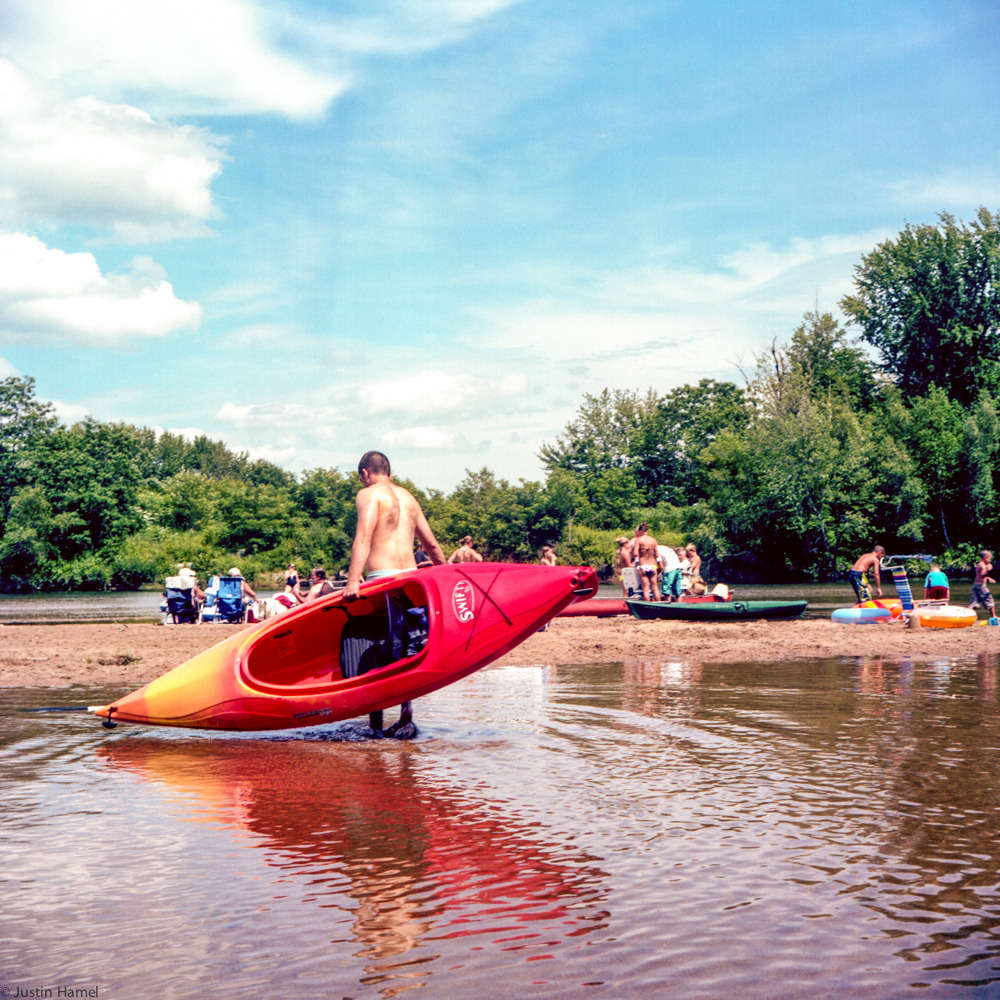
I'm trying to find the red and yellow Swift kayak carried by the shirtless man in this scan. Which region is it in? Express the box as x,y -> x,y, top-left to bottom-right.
91,563 -> 597,730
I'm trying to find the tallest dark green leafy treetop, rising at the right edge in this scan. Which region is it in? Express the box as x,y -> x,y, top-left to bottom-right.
840,208 -> 1000,405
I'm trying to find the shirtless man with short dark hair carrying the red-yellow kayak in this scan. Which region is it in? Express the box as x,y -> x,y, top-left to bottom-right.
344,451 -> 450,738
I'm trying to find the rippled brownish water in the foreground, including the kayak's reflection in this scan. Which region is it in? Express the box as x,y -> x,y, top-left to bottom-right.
0,657 -> 1000,1000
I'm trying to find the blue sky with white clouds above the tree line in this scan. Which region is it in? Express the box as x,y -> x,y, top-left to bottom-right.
0,0 -> 1000,491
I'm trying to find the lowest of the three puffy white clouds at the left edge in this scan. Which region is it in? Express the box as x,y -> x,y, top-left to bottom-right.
0,233 -> 201,346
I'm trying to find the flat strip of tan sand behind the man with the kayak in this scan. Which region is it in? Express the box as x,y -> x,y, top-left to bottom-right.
0,618 -> 1000,688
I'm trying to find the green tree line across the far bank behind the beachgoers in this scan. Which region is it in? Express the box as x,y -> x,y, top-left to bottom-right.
0,208 -> 1000,591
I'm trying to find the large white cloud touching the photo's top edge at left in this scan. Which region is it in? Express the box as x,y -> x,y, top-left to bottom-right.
0,0 -> 347,118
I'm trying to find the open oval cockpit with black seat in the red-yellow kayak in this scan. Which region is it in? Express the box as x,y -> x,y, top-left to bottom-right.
241,579 -> 428,694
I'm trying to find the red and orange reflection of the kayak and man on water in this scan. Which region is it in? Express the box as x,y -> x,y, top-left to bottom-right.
99,738 -> 608,995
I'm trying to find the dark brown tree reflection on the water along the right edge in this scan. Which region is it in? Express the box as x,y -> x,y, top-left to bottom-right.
856,653 -> 1000,985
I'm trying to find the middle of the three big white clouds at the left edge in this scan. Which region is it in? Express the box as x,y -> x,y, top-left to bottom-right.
0,59 -> 224,241
